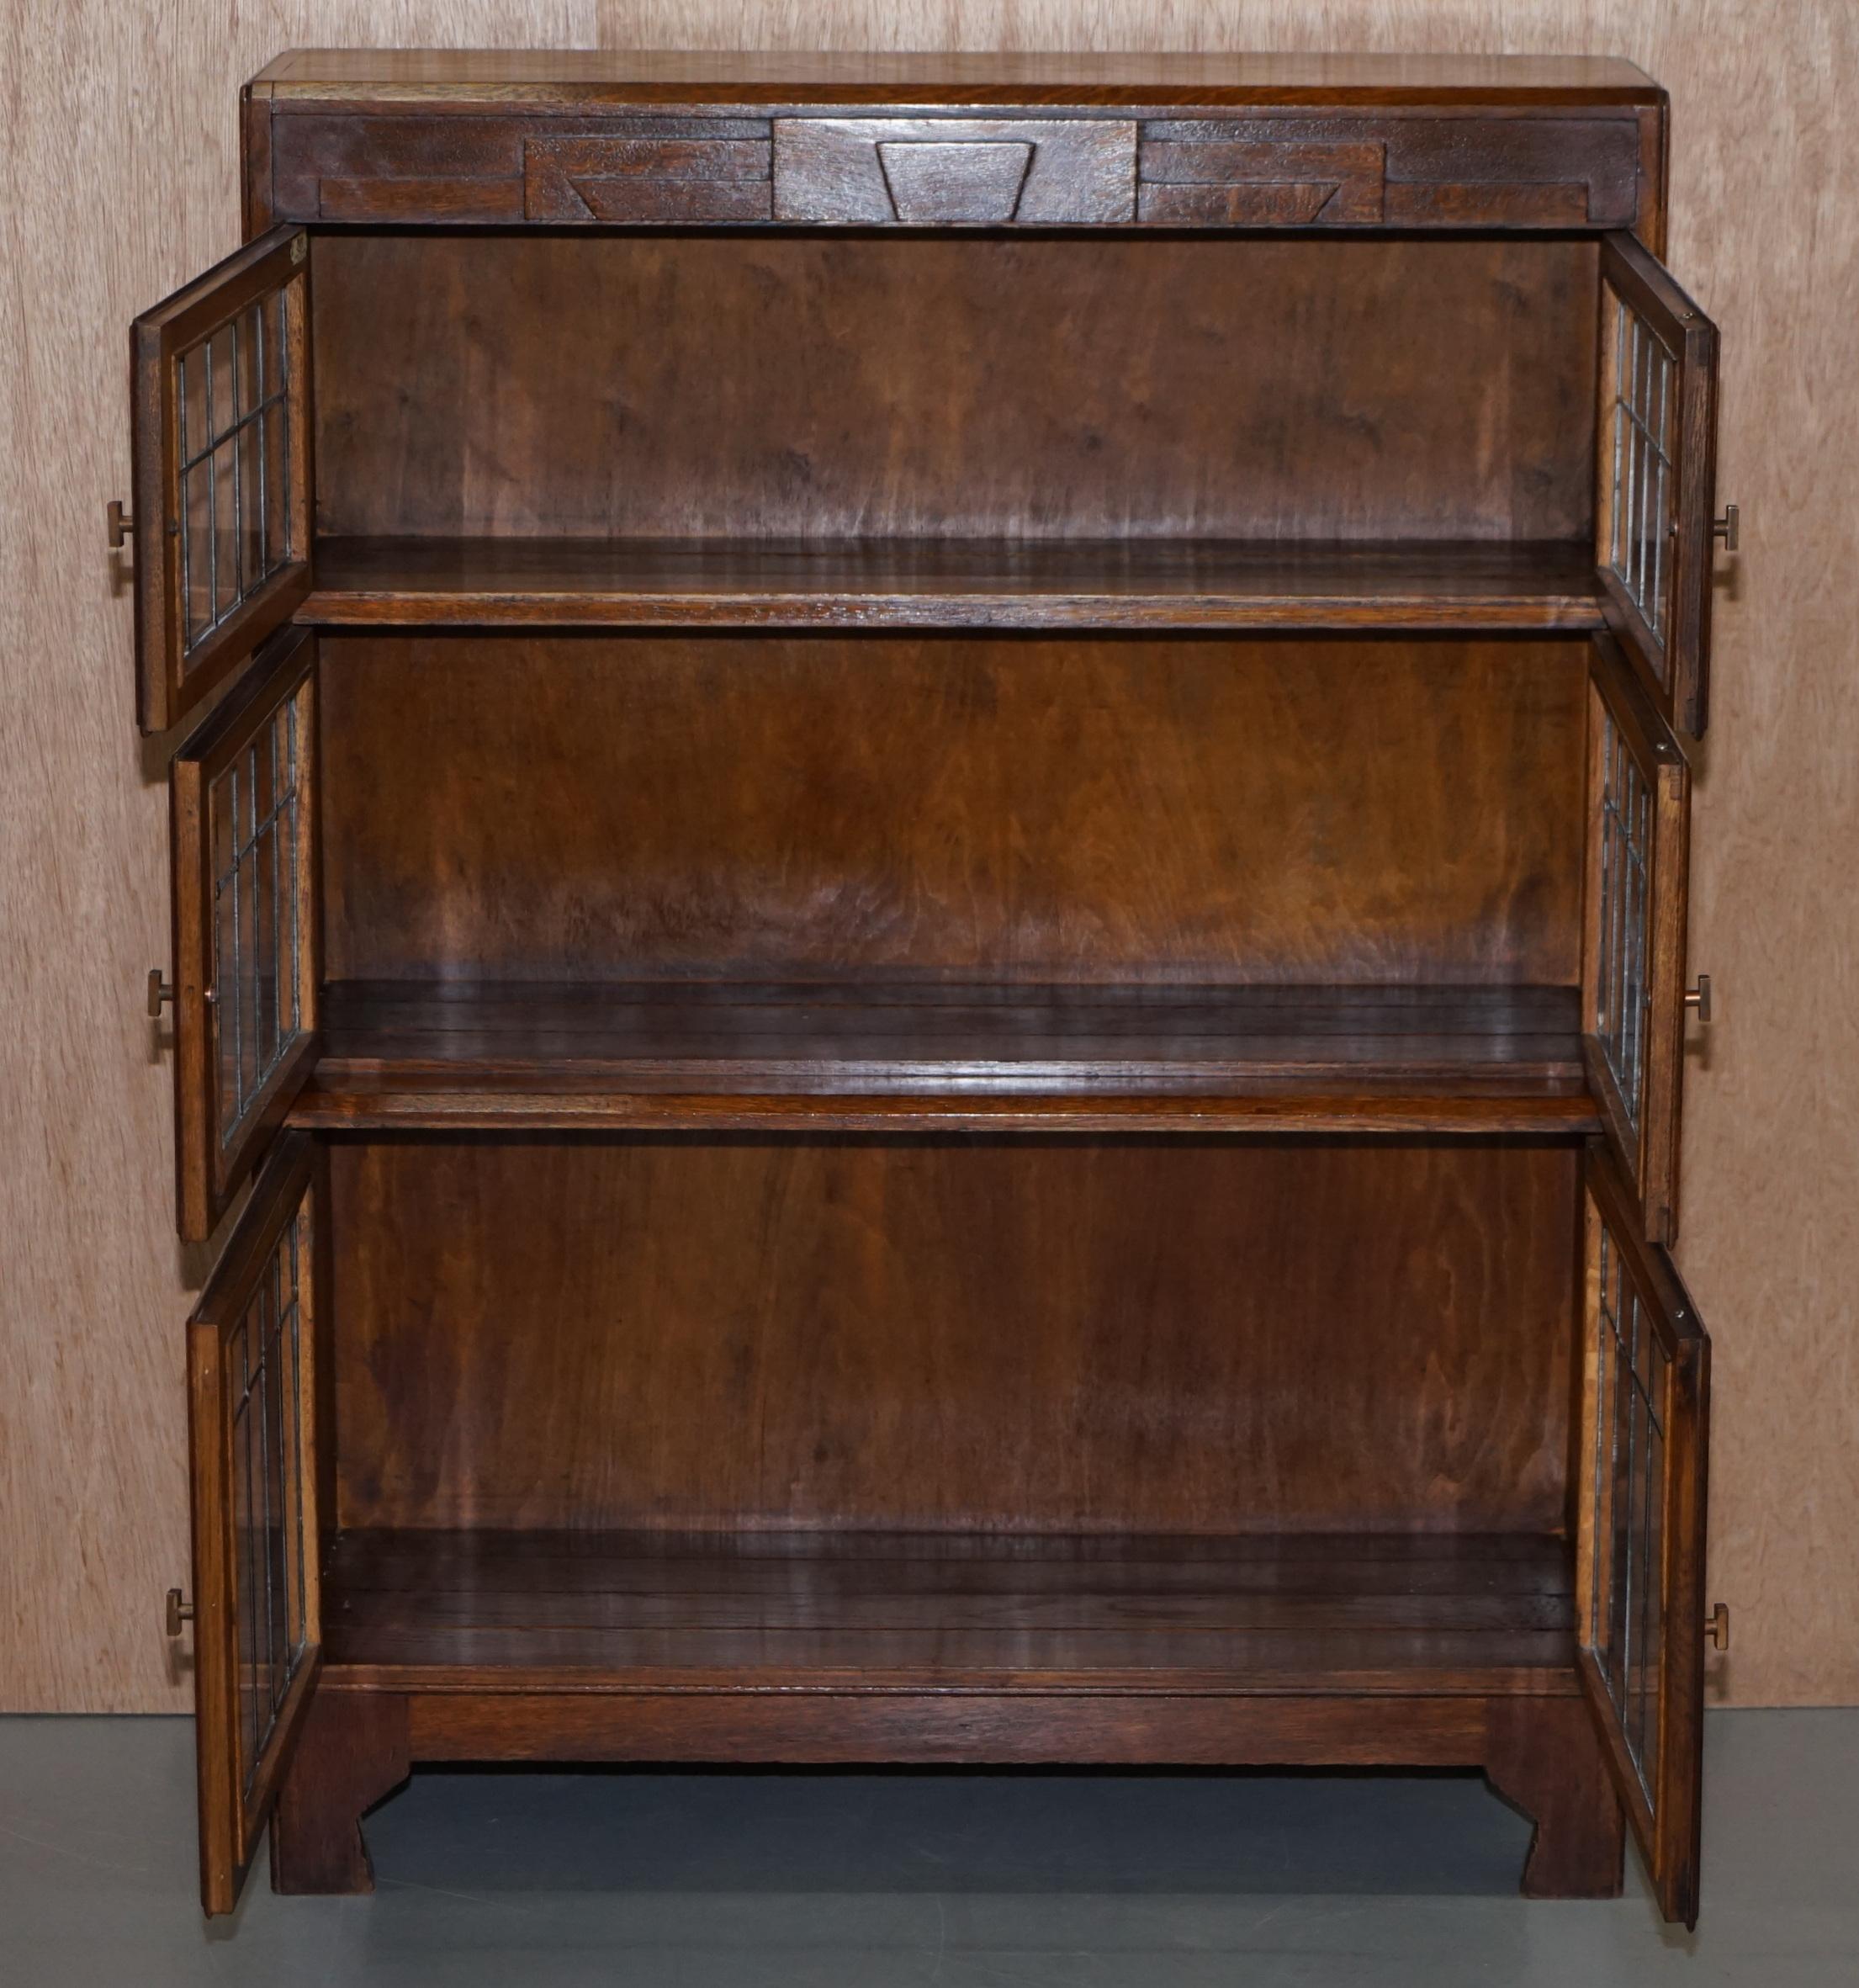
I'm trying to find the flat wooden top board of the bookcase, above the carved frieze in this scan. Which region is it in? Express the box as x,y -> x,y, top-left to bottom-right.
252,48 -> 1662,108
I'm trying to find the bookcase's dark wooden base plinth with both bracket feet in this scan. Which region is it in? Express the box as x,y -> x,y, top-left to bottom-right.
273,1670 -> 1624,1899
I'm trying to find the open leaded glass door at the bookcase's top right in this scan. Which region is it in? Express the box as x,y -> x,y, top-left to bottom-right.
1595,235 -> 1718,738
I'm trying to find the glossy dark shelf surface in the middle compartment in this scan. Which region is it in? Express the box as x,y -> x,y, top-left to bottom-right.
324,980 -> 1582,1089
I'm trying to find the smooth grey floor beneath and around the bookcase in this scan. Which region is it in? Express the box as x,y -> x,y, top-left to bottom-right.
0,1710 -> 1859,1988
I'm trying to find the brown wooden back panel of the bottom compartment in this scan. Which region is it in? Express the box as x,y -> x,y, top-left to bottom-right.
332,1139 -> 1576,1533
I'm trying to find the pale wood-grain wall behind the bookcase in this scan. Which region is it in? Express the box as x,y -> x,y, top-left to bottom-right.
0,0 -> 1859,1712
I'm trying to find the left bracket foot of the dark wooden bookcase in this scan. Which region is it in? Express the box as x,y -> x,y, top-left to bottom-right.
270,1672 -> 411,1896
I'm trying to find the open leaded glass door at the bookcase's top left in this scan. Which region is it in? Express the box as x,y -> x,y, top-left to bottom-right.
131,229 -> 310,732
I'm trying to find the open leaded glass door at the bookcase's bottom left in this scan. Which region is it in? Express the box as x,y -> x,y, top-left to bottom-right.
187,1133 -> 322,1912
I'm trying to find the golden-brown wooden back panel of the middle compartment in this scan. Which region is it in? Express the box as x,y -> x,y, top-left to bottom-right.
320,634 -> 1586,986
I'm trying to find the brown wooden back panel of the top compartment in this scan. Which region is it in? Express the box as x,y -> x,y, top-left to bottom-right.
314,232 -> 1597,538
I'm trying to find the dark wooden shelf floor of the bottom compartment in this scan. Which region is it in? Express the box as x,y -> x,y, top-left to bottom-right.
322,1531 -> 1575,1694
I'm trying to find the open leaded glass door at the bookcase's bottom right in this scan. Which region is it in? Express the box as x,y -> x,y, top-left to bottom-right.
1575,1145 -> 1710,1924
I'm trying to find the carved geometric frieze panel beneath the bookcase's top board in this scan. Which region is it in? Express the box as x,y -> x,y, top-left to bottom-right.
272,108 -> 1662,242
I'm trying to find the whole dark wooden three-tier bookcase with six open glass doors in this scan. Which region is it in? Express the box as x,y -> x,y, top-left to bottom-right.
127,54 -> 1734,1921
